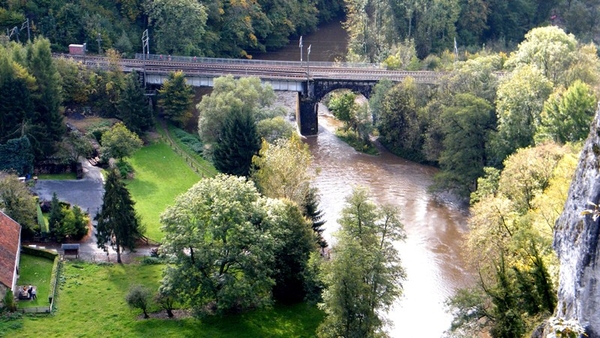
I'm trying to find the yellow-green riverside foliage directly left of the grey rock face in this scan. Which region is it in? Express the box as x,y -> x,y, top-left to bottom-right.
448,144 -> 578,337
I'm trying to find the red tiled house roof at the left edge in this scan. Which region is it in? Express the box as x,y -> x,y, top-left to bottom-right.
0,211 -> 21,289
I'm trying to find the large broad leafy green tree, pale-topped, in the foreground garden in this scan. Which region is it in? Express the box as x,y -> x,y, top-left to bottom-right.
161,175 -> 275,314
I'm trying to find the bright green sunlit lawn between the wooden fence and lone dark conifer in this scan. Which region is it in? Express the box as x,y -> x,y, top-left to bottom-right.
127,141 -> 200,241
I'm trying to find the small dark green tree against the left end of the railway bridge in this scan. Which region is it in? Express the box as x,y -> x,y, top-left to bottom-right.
158,71 -> 194,126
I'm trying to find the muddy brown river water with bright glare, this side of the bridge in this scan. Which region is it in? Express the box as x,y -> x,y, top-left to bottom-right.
306,114 -> 470,337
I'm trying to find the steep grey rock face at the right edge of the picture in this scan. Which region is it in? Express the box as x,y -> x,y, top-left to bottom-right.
554,110 -> 600,338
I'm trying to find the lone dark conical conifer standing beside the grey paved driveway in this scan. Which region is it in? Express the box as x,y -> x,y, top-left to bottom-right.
95,169 -> 143,263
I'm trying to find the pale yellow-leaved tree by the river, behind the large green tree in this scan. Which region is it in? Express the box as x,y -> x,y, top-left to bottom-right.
252,134 -> 312,205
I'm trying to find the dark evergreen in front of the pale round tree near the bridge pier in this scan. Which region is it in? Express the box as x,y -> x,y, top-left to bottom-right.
213,108 -> 260,176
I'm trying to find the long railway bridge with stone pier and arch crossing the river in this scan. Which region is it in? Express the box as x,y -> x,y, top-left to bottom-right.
63,54 -> 444,136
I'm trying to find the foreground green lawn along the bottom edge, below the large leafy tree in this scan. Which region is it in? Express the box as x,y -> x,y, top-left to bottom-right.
0,262 -> 323,338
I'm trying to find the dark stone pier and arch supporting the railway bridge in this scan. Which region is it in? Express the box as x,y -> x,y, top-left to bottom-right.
296,79 -> 377,136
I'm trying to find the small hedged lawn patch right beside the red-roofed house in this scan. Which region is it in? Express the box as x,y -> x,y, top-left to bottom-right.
17,254 -> 54,308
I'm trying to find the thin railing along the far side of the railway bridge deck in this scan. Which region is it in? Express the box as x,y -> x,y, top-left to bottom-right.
135,53 -> 382,69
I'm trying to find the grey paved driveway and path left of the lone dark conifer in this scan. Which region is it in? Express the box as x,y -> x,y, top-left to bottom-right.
31,160 -> 153,263
